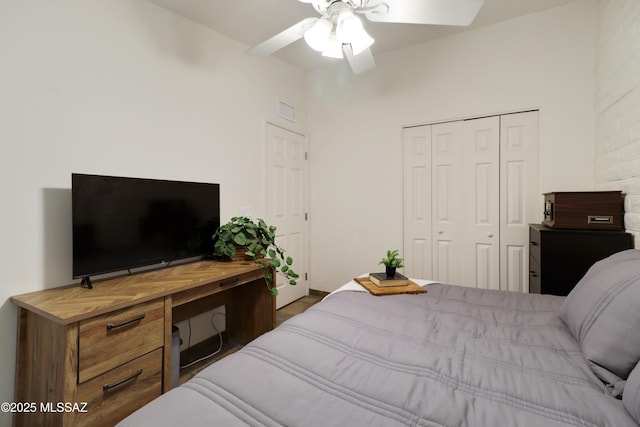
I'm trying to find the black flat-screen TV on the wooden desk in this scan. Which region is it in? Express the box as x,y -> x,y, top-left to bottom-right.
71,174 -> 220,278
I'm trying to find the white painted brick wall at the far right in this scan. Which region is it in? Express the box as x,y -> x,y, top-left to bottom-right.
596,0 -> 640,248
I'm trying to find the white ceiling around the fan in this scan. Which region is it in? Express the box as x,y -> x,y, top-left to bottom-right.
148,0 -> 576,70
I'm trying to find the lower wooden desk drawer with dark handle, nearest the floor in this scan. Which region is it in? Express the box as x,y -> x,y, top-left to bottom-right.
73,348 -> 162,426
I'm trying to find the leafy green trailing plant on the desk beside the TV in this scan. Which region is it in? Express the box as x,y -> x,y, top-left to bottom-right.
213,216 -> 300,296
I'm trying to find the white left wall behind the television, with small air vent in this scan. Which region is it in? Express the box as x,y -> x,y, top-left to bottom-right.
0,0 -> 307,425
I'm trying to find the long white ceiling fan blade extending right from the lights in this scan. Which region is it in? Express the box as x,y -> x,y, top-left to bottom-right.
364,0 -> 484,26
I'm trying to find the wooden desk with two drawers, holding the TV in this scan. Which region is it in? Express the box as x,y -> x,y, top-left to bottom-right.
11,261 -> 276,426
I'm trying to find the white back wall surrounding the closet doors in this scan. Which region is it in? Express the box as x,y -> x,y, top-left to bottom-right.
309,0 -> 596,291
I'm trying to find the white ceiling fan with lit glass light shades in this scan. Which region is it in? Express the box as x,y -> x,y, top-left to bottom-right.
247,0 -> 484,74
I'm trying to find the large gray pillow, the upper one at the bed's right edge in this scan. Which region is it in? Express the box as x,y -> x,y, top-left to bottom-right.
561,249 -> 640,384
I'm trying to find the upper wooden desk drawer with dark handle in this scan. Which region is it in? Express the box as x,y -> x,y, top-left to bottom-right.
78,299 -> 164,383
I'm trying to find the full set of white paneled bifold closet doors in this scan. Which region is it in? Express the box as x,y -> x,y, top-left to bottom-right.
403,111 -> 539,292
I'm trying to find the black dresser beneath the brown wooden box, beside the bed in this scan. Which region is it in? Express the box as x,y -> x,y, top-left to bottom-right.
529,224 -> 633,296
